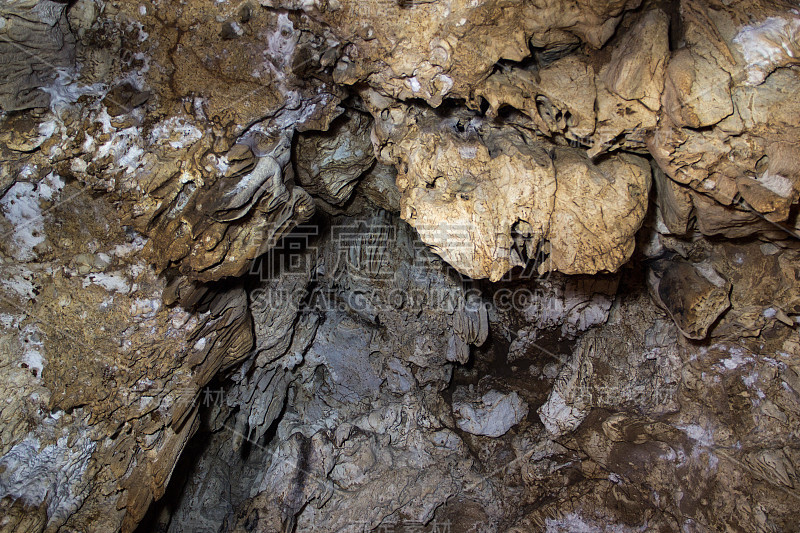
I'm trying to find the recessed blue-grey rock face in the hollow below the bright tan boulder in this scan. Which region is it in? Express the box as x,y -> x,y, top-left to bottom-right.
152,215 -> 494,531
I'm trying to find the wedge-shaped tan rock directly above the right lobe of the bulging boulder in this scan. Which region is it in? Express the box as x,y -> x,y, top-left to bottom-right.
475,10 -> 669,157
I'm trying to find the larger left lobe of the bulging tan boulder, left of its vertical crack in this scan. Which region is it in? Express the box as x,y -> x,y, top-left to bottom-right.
393,110 -> 556,280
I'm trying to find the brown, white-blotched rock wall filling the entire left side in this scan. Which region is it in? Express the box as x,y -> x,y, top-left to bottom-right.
1,2 -> 339,531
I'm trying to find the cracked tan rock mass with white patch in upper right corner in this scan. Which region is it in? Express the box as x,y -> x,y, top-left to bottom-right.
647,1 -> 798,231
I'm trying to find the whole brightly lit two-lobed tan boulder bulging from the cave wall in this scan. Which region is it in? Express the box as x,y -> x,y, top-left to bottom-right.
368,102 -> 650,281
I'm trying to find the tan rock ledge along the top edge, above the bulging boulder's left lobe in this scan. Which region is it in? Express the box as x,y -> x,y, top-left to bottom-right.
264,0 -> 639,107
